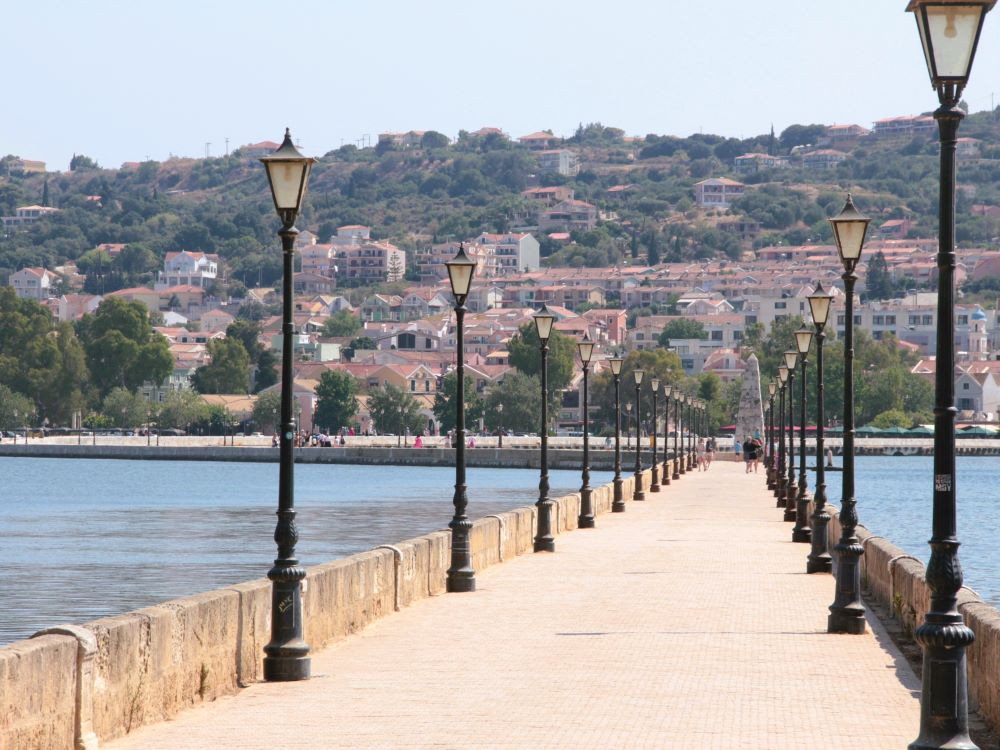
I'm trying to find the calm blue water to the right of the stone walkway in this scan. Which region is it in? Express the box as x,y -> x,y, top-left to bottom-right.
809,456 -> 1000,605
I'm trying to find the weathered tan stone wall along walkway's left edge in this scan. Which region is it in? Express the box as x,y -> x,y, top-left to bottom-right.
0,468 -> 652,750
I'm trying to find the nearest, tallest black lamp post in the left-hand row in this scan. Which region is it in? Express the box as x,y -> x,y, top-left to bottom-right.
260,129 -> 313,681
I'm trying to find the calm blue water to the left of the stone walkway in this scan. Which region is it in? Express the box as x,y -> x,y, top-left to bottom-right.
0,458 -> 612,643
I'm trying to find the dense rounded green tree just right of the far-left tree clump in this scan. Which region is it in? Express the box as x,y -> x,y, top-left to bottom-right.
77,297 -> 174,395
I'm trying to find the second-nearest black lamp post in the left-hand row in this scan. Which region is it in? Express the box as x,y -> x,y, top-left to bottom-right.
445,243 -> 476,592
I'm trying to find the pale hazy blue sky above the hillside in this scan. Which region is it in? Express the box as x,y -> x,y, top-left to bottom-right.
0,0 -> 1000,169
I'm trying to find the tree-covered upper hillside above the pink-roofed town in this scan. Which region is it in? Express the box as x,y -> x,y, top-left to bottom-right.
0,116 -> 1000,296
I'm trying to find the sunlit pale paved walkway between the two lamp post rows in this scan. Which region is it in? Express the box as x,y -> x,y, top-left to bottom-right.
103,462 -> 919,750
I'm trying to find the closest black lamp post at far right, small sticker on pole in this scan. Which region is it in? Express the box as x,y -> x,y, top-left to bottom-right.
906,0 -> 995,750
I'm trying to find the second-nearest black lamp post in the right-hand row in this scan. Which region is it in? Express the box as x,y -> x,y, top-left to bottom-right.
827,194 -> 871,634
